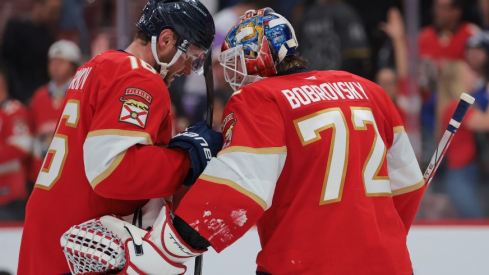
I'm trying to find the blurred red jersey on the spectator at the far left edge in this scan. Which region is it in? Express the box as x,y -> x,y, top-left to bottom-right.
0,99 -> 32,205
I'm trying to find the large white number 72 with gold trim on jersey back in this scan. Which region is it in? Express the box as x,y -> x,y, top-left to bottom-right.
294,107 -> 392,205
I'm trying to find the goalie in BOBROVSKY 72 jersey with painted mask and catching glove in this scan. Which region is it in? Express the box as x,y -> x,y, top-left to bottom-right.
62,8 -> 425,275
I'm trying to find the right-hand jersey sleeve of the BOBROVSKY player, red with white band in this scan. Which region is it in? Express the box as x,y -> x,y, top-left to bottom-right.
382,85 -> 426,231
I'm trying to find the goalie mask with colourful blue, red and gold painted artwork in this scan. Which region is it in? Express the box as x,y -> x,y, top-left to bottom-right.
219,8 -> 299,91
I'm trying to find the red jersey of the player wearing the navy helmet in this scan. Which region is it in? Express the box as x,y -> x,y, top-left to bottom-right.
18,51 -> 190,275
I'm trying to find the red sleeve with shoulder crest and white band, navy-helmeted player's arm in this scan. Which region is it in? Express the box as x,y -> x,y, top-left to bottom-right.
83,67 -> 190,199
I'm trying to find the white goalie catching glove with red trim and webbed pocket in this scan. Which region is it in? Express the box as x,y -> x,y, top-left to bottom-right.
61,206 -> 206,275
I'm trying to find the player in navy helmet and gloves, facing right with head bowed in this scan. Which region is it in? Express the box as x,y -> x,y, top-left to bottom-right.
18,0 -> 222,275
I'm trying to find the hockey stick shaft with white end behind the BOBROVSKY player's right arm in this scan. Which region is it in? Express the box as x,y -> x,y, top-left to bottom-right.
423,93 -> 475,186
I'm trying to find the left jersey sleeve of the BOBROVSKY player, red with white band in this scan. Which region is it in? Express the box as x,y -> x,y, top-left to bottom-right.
176,90 -> 287,252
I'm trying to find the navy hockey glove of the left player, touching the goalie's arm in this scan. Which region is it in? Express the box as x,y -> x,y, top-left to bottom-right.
168,121 -> 223,186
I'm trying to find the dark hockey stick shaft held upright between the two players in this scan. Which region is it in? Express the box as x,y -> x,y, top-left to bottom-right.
194,47 -> 214,275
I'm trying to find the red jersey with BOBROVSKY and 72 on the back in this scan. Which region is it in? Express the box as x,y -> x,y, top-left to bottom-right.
175,71 -> 424,275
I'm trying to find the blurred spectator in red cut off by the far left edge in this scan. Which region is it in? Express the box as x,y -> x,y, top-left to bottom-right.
0,61 -> 32,221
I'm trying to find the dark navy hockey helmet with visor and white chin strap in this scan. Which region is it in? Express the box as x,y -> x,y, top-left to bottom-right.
136,0 -> 215,73
